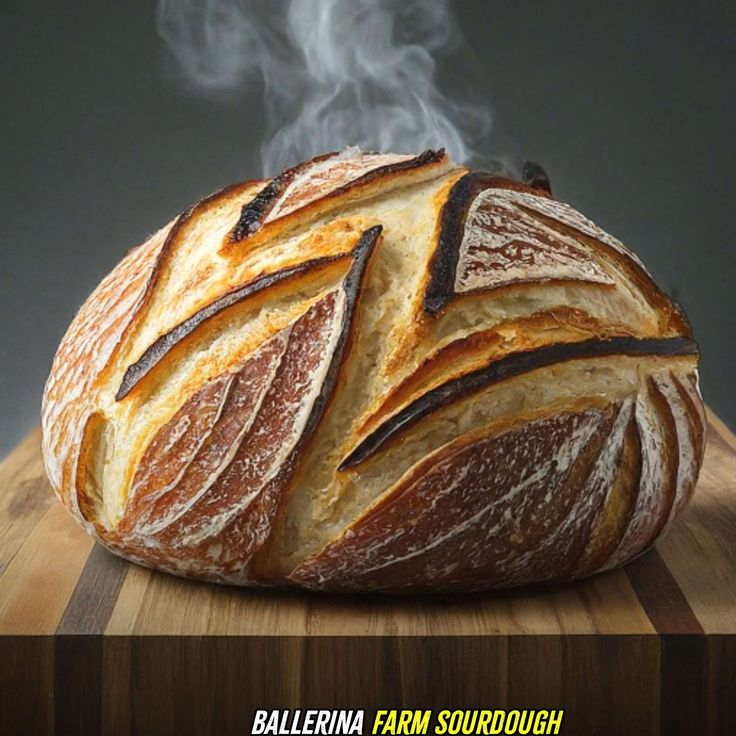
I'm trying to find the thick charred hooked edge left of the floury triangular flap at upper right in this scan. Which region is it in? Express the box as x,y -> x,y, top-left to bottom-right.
424,171 -> 540,314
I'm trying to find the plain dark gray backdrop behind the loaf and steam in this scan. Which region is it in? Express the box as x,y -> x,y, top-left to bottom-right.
0,0 -> 736,455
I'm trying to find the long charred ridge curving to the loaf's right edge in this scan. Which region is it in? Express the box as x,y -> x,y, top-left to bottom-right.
339,337 -> 698,470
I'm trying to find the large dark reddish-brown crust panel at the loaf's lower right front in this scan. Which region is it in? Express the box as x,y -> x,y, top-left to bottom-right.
292,407 -> 617,591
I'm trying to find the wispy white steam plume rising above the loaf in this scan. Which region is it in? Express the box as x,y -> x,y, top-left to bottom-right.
156,0 -> 491,175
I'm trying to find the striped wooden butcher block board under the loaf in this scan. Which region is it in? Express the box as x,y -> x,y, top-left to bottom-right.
0,412 -> 736,736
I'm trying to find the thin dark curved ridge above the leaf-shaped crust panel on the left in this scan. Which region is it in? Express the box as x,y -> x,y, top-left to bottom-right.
115,254 -> 346,401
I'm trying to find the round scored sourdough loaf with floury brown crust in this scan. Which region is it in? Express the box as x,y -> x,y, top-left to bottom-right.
43,149 -> 705,591
